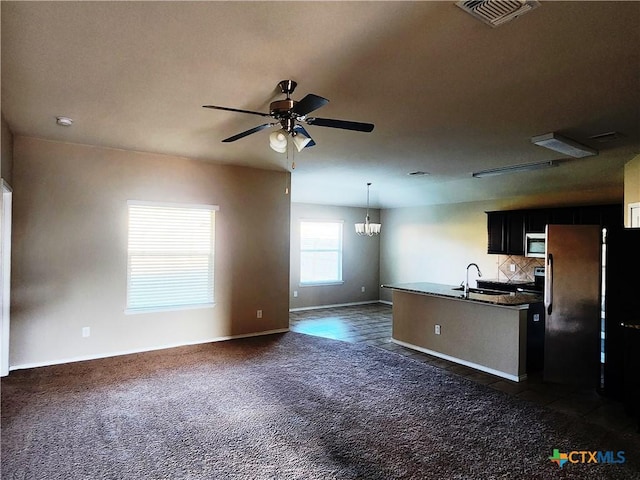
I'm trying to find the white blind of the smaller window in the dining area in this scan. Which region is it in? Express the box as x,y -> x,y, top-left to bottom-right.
300,221 -> 342,285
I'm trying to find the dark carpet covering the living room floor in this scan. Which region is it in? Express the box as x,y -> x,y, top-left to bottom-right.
2,333 -> 640,480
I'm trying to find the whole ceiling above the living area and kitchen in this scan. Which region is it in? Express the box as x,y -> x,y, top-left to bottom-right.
2,1 -> 640,207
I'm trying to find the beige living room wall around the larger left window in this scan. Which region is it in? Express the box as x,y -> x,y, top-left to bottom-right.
10,136 -> 290,368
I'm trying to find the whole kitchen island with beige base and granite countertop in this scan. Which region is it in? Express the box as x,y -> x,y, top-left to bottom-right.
382,282 -> 542,382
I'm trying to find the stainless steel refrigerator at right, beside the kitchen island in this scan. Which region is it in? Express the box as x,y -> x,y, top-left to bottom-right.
543,225 -> 602,387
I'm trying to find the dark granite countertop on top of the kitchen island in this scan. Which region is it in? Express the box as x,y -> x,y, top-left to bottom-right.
382,282 -> 542,309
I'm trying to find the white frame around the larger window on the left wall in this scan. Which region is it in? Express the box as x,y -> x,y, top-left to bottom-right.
125,200 -> 220,314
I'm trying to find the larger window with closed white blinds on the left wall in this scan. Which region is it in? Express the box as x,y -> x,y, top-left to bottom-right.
127,201 -> 218,313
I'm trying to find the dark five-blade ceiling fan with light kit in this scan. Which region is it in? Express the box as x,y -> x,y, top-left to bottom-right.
203,80 -> 374,153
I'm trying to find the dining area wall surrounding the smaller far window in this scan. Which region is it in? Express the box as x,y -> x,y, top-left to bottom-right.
289,203 -> 385,309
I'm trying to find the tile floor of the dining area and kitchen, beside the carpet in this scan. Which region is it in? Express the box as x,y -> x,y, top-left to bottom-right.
289,303 -> 637,432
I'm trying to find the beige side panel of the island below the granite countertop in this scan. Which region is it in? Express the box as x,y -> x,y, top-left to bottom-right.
392,290 -> 527,378
